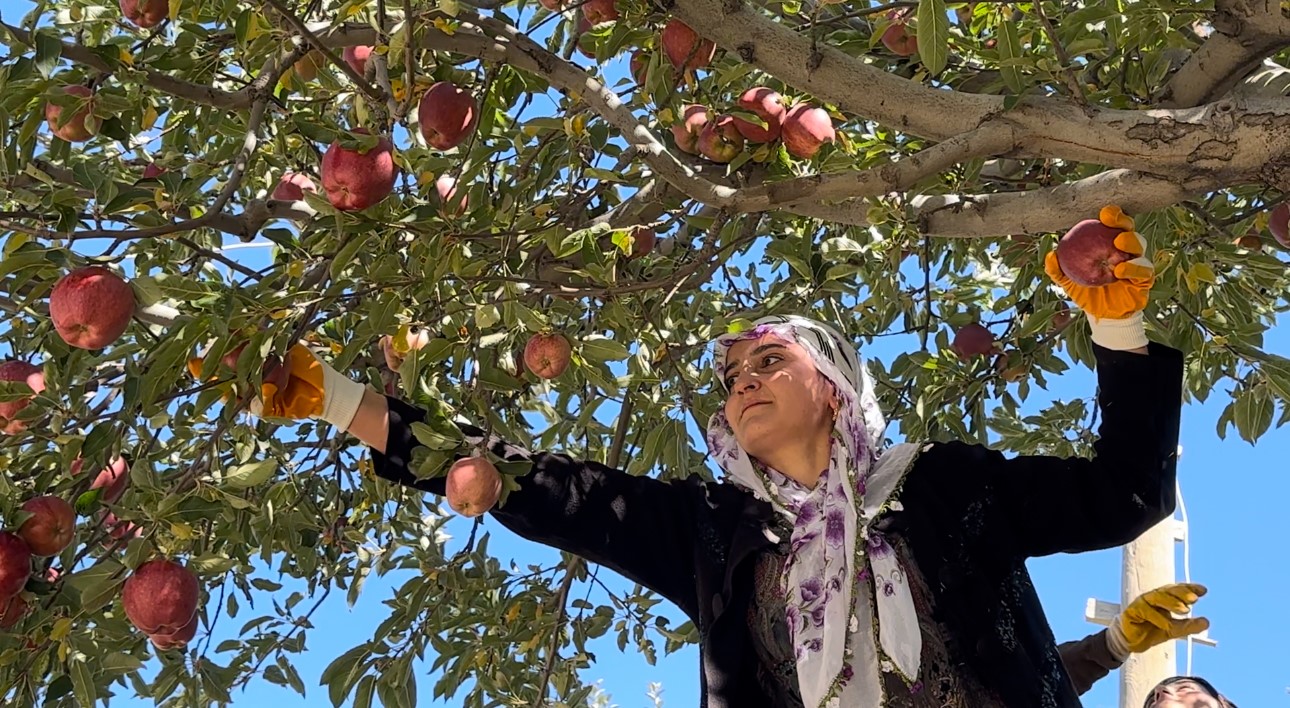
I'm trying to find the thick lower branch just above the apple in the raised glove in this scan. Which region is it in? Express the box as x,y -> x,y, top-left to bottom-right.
911,170 -> 1222,237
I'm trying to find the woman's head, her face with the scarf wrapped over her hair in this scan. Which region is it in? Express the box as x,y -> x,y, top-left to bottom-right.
716,316 -> 884,487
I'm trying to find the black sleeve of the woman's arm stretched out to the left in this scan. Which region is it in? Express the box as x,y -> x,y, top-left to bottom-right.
372,396 -> 702,619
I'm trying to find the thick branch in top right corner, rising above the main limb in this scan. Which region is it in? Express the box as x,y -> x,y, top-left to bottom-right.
1157,0 -> 1290,108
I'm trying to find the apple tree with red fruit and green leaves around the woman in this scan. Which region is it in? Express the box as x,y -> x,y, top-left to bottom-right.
0,0 -> 1290,705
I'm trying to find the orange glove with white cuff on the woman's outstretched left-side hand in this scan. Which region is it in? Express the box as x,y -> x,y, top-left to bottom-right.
188,344 -> 366,431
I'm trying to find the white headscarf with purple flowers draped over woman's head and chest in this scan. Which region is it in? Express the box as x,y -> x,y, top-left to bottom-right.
708,316 -> 922,708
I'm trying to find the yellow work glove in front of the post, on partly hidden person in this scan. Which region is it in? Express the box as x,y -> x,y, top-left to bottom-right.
1107,583 -> 1209,660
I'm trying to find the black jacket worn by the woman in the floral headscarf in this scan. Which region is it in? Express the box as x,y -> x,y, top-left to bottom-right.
374,344 -> 1183,708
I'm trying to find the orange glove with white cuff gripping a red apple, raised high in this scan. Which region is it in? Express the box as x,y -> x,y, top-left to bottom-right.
1044,205 -> 1156,349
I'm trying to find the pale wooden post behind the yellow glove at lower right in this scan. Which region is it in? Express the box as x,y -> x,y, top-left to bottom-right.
1120,516 -> 1178,708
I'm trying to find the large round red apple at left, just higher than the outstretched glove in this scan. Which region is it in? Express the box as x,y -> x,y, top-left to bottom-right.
49,266 -> 134,349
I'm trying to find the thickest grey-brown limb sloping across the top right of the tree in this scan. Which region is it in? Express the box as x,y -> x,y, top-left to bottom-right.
672,0 -> 1290,177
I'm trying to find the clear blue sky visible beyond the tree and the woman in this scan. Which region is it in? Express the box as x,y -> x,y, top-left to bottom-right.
0,0 -> 1290,708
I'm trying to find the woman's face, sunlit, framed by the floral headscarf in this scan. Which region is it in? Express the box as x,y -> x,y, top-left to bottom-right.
721,334 -> 837,462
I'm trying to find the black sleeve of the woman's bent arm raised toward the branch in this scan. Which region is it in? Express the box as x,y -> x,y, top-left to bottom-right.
924,343 -> 1183,557
